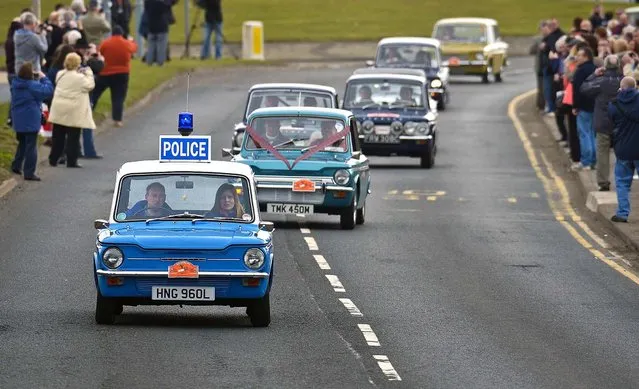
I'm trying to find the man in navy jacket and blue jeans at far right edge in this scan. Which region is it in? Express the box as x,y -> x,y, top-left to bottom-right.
608,77 -> 639,223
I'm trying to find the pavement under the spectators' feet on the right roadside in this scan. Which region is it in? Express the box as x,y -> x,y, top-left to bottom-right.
544,112 -> 639,250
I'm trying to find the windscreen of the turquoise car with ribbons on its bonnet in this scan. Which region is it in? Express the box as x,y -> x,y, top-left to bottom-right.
246,116 -> 348,152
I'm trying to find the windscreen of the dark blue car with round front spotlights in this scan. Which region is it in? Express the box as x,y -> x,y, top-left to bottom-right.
344,79 -> 425,109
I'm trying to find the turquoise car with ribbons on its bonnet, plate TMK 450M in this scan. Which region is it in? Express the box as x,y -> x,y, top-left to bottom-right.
223,107 -> 370,229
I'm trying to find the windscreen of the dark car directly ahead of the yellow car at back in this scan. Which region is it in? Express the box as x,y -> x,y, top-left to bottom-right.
375,44 -> 439,68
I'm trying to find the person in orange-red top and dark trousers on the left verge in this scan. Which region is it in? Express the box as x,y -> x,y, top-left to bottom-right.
92,25 -> 138,127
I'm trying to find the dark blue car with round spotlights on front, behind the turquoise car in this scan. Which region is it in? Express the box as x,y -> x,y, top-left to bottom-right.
342,69 -> 437,169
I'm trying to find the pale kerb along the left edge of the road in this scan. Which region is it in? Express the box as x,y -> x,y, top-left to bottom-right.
0,65 -> 264,199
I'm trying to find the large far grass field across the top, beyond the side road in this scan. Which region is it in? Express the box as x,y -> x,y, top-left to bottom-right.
0,0 -> 630,43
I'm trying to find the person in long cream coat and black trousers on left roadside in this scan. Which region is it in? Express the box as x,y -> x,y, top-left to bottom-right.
49,53 -> 96,168
